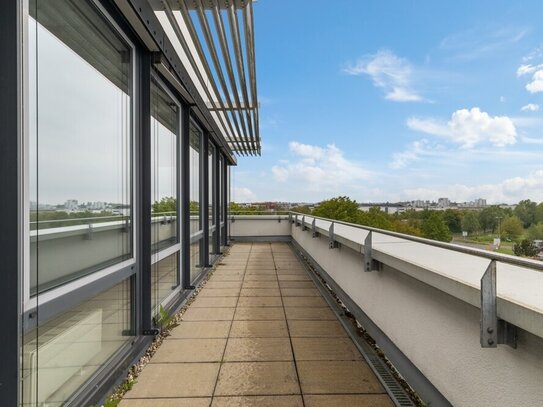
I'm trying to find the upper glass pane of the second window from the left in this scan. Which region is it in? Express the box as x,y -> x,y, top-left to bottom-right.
151,80 -> 179,252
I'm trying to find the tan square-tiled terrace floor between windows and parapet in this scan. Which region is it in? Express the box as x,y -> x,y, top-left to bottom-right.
121,243 -> 393,407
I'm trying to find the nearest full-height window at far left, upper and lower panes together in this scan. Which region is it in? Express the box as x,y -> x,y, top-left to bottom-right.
22,0 -> 137,406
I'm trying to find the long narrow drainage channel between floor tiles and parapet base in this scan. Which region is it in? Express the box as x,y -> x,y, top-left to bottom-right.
290,243 -> 424,407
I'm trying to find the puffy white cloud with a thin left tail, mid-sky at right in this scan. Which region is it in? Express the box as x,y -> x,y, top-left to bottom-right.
407,107 -> 517,148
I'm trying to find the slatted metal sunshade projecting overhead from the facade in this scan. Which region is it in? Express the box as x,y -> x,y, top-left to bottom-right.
151,0 -> 261,155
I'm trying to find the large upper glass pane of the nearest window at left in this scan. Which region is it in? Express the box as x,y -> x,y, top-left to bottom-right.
28,0 -> 133,294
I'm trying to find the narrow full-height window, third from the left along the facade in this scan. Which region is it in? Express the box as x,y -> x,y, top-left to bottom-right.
189,122 -> 203,281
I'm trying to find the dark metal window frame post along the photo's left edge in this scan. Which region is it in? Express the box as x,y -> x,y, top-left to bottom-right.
0,0 -> 21,406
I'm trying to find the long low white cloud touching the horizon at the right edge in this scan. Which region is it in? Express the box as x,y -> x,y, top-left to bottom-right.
402,169 -> 543,203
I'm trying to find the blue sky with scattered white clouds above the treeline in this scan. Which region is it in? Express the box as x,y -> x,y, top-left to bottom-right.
232,0 -> 543,203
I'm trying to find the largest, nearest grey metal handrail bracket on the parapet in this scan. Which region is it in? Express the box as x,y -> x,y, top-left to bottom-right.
481,260 -> 518,349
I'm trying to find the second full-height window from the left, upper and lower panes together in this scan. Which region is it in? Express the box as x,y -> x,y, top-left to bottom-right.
150,79 -> 180,315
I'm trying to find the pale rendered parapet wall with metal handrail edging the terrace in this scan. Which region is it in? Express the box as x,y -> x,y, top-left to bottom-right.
229,212 -> 543,406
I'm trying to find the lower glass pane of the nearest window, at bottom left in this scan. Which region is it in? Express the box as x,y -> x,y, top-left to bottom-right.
22,280 -> 133,406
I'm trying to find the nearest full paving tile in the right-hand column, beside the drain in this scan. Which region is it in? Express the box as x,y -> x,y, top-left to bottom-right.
296,361 -> 385,394
